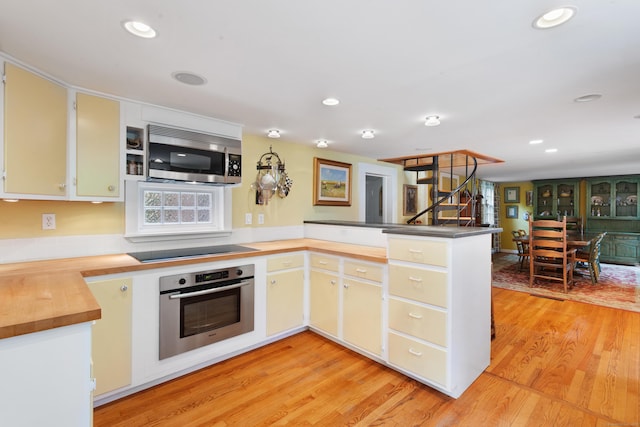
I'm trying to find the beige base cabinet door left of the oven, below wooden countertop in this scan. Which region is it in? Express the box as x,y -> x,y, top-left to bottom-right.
88,278 -> 132,396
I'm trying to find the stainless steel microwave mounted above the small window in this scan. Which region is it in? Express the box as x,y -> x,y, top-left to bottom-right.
147,125 -> 242,184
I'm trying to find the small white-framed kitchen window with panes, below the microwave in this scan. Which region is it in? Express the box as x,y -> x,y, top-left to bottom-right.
125,181 -> 231,241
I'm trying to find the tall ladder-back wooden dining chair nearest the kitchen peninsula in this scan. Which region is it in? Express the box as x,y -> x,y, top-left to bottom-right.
529,218 -> 576,292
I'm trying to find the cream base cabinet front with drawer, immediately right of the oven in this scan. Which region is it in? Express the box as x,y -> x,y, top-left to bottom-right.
267,253 -> 304,336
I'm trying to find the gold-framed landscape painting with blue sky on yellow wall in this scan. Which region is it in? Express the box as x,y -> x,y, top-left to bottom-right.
313,157 -> 351,206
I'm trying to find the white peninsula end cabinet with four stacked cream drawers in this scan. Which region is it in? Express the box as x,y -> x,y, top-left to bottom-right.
387,234 -> 491,398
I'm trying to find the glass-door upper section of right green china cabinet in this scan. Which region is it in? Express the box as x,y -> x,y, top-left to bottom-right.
587,177 -> 640,219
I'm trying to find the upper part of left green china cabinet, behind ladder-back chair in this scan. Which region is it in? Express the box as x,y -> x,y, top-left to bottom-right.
533,179 -> 580,219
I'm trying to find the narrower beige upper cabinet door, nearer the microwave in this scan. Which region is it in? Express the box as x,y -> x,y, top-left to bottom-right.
75,93 -> 121,198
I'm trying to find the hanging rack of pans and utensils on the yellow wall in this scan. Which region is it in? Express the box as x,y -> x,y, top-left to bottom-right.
251,146 -> 293,205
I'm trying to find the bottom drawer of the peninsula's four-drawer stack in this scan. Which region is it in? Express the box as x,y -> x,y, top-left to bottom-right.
389,332 -> 447,386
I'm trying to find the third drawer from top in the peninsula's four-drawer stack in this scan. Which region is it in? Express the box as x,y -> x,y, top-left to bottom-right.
389,298 -> 447,347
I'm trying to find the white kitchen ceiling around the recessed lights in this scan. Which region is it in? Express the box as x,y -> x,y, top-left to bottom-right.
0,0 -> 640,182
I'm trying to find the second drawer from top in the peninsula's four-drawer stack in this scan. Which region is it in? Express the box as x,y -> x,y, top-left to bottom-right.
389,264 -> 447,308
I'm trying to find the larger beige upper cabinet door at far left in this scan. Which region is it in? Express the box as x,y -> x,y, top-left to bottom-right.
4,62 -> 68,199
